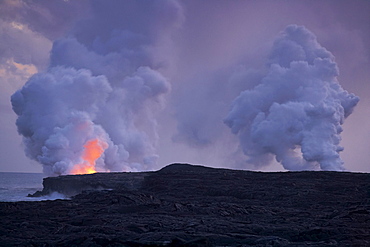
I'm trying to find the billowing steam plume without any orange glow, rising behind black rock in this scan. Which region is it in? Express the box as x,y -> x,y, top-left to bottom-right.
225,25 -> 359,170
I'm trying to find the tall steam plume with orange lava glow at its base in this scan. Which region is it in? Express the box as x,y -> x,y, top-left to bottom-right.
11,0 -> 182,175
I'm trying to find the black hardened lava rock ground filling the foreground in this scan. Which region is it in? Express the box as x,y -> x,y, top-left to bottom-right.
0,164 -> 370,246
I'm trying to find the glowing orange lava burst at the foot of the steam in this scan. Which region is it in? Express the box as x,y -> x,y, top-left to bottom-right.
71,139 -> 108,174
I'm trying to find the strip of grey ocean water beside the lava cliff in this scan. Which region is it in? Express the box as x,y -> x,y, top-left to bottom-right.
0,172 -> 65,202
